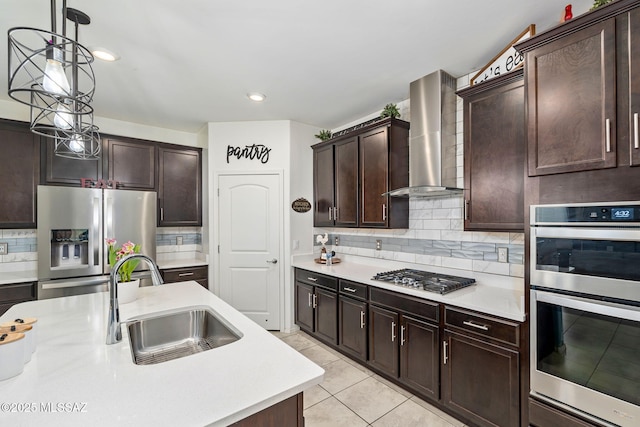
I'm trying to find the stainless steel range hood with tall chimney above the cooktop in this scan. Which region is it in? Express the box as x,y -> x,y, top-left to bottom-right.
386,70 -> 463,197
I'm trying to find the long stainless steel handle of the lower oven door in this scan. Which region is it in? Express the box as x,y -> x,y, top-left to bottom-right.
531,290 -> 640,322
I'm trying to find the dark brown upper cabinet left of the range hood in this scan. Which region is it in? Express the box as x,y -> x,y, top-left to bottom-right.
313,119 -> 409,228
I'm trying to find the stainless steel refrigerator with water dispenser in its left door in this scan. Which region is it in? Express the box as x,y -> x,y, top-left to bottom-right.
37,185 -> 157,299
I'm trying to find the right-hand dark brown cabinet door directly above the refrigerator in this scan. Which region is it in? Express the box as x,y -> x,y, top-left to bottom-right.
102,136 -> 158,191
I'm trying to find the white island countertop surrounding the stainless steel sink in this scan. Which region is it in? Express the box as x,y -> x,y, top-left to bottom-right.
0,281 -> 324,427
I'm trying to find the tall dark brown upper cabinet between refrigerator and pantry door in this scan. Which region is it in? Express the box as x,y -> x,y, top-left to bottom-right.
158,145 -> 202,227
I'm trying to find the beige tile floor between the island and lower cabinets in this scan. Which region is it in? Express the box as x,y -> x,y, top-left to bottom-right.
274,332 -> 464,427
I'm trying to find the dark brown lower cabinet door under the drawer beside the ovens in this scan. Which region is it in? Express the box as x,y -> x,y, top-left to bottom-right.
442,330 -> 520,427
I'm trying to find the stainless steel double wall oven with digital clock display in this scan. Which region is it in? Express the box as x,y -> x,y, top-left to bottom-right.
530,201 -> 640,426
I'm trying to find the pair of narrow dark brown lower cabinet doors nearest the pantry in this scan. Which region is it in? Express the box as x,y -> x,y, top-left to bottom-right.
295,281 -> 338,345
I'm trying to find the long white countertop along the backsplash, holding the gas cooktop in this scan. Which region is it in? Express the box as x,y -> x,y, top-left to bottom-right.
292,256 -> 525,322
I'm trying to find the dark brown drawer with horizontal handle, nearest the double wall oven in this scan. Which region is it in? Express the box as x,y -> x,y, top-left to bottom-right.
444,307 -> 520,346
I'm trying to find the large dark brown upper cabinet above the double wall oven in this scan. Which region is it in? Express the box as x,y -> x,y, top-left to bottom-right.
517,0 -> 640,176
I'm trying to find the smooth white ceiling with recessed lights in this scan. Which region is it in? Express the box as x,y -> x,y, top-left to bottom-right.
0,0 -> 593,132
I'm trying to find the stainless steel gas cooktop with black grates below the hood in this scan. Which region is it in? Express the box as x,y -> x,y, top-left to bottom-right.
373,268 -> 476,294
